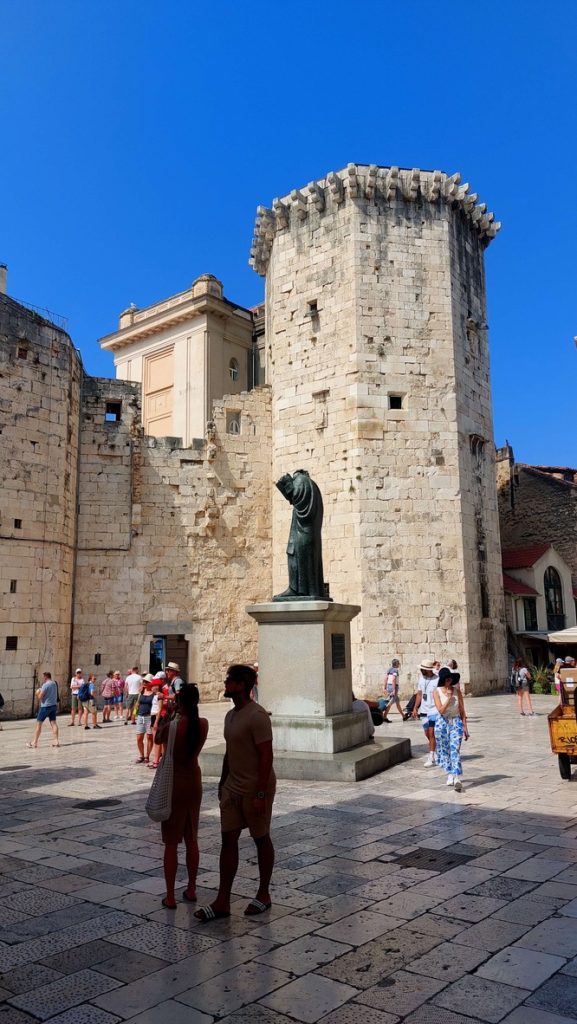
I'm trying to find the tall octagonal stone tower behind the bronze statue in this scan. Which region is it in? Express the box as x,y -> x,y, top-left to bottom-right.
251,164 -> 506,694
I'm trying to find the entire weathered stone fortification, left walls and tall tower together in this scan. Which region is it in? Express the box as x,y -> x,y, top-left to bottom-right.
0,157 -> 506,715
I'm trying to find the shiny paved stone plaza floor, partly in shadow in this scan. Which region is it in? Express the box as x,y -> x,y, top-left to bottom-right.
0,695 -> 577,1024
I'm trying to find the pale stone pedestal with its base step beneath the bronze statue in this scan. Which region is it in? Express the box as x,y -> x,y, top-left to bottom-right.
208,601 -> 411,781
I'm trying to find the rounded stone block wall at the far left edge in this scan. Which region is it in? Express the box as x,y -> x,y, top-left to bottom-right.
0,295 -> 82,716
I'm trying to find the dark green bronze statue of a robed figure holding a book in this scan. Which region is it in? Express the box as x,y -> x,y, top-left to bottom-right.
273,469 -> 331,601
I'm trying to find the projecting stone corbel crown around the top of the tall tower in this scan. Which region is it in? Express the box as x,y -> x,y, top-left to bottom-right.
249,164 -> 501,276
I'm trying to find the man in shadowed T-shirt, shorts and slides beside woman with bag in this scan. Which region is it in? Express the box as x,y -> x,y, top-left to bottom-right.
195,665 -> 277,922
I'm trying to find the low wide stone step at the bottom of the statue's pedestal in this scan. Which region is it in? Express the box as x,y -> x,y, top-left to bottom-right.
199,738 -> 411,782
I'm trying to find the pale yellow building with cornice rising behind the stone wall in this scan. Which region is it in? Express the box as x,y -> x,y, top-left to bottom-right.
100,273 -> 258,446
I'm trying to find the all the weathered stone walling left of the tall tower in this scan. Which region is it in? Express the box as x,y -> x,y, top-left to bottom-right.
0,288 -> 272,715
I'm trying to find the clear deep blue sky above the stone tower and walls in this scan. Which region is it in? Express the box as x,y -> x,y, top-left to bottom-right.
0,0 -> 577,465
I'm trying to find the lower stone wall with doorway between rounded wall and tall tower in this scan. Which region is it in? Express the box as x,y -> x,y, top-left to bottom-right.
74,381 -> 272,699
